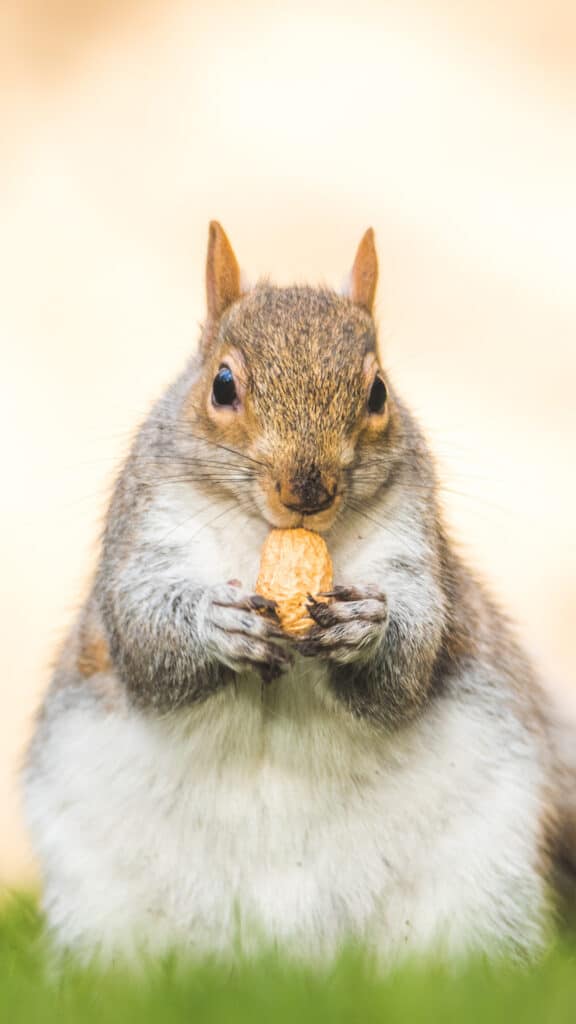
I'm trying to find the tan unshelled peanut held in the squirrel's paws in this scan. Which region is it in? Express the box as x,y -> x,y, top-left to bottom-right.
256,529 -> 332,636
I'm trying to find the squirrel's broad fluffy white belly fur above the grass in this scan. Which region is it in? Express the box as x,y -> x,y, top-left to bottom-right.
28,667 -> 542,961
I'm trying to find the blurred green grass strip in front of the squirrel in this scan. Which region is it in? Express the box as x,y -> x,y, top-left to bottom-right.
0,897 -> 576,1024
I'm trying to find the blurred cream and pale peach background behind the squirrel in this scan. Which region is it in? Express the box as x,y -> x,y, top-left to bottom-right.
0,0 -> 576,885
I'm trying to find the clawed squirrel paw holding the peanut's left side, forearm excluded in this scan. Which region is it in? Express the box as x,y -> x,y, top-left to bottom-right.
199,581 -> 293,682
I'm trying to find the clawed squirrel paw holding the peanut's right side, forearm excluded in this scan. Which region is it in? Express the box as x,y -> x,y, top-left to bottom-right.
296,584 -> 388,665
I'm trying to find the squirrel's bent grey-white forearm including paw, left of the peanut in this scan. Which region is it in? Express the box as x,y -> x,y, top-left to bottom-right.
97,563 -> 292,712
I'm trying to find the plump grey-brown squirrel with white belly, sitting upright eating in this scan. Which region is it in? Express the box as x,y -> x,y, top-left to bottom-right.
24,222 -> 576,965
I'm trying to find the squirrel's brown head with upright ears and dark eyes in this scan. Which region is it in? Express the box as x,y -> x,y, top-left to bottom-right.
184,222 -> 396,531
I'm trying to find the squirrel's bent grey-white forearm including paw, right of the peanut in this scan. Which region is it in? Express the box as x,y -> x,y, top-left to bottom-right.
297,564 -> 445,727
